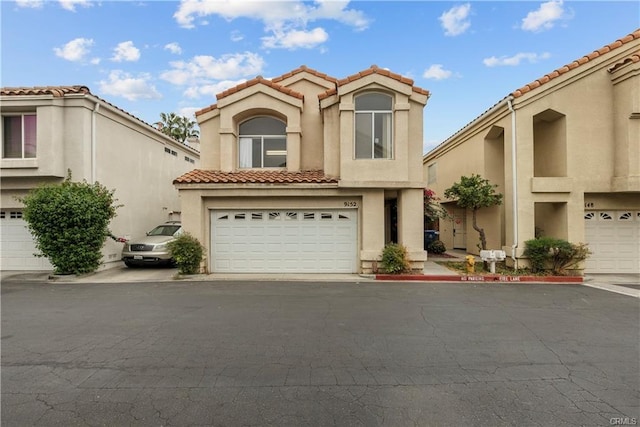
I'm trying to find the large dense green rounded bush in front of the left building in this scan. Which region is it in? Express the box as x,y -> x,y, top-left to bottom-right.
19,172 -> 119,274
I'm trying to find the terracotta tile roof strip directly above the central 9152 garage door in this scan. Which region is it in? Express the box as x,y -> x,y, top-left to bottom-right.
173,169 -> 338,184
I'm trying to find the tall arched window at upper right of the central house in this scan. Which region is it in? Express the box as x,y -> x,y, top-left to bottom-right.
355,92 -> 393,159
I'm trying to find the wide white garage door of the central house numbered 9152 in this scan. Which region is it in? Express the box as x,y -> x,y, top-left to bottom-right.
211,210 -> 358,273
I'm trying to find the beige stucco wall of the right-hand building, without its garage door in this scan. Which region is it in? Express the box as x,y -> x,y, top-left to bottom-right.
423,35 -> 640,266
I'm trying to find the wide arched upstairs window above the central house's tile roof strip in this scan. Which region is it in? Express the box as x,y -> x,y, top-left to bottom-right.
238,116 -> 287,168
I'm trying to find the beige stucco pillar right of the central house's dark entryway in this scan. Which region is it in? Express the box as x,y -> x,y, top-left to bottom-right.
398,188 -> 427,270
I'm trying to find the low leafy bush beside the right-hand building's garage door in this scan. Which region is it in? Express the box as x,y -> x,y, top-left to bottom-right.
524,237 -> 591,274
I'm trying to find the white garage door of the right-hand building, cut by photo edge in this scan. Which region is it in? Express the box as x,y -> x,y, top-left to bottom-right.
584,211 -> 640,274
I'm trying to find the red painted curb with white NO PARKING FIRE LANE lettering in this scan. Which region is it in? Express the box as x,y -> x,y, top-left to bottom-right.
376,274 -> 583,283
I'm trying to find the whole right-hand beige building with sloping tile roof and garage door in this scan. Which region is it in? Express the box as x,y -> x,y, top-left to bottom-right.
423,30 -> 640,273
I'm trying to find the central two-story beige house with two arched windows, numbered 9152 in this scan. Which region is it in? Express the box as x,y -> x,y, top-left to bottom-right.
174,66 -> 429,273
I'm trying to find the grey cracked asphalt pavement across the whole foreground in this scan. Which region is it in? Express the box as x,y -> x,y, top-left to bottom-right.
1,281 -> 640,426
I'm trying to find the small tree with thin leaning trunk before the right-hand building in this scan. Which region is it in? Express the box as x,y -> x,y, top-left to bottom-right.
444,174 -> 502,250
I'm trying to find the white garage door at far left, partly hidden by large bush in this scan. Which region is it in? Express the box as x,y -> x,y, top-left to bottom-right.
0,210 -> 53,271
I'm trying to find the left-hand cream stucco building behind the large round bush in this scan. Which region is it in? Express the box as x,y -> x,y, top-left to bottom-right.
0,86 -> 200,270
